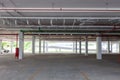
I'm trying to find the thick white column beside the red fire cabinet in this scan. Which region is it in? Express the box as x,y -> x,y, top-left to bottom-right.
19,32 -> 24,60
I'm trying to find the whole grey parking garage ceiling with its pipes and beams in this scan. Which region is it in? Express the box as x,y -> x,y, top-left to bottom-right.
0,0 -> 120,39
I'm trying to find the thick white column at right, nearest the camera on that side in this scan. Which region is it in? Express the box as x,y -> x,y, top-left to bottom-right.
96,37 -> 102,60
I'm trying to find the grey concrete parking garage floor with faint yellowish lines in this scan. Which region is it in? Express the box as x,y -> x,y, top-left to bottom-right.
0,54 -> 120,80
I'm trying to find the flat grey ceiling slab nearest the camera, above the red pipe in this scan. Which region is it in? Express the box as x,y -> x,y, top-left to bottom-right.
1,0 -> 120,8
